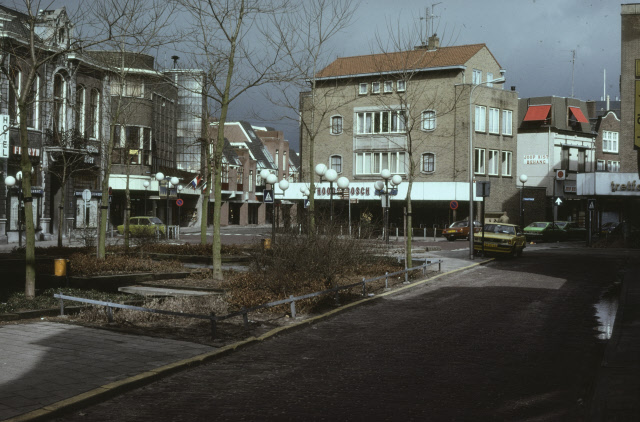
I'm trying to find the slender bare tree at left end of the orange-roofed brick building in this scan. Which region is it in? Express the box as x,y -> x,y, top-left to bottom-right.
267,0 -> 359,235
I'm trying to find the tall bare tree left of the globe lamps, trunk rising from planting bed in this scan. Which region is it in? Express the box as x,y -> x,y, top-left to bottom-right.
176,0 -> 288,280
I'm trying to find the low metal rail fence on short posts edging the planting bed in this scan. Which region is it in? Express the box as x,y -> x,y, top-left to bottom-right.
53,260 -> 442,338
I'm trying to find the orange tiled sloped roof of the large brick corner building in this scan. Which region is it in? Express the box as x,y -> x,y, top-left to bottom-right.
316,44 -> 490,78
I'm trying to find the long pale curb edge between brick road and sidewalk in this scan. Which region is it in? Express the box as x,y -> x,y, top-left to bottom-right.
4,258 -> 494,422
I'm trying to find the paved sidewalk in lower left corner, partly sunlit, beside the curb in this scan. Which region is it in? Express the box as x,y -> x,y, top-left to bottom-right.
0,322 -> 212,420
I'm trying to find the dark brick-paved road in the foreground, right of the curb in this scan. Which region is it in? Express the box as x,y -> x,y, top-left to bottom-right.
59,249 -> 621,421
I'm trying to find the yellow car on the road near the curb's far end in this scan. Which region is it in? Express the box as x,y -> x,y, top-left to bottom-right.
473,223 -> 527,257
